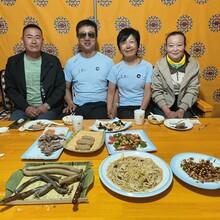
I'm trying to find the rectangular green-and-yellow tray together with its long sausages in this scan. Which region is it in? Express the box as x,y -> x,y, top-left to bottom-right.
0,162 -> 94,205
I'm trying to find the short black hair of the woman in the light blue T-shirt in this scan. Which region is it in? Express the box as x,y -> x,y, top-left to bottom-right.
117,28 -> 141,50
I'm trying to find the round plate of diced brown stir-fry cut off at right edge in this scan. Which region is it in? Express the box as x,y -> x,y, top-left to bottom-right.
170,152 -> 220,190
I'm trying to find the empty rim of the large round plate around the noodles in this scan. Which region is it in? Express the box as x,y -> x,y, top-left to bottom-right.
99,151 -> 173,198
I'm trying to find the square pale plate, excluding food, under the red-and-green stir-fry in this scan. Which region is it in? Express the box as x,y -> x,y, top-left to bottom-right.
105,130 -> 157,154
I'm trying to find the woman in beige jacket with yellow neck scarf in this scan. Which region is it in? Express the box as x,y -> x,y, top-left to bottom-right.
152,31 -> 200,118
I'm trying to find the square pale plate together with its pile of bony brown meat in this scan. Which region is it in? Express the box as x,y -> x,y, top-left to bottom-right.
21,127 -> 70,160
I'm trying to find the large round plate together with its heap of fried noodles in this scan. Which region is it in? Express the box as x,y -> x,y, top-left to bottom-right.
99,151 -> 173,198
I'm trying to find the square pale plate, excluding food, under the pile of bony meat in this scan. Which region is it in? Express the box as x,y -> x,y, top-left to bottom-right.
21,127 -> 71,160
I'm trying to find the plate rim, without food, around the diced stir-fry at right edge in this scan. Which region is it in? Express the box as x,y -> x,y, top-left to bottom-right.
170,152 -> 220,189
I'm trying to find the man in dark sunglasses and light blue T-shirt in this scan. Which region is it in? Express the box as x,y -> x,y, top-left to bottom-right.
63,20 -> 114,119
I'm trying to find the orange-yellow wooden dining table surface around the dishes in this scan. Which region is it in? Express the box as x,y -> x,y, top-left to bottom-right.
0,118 -> 220,220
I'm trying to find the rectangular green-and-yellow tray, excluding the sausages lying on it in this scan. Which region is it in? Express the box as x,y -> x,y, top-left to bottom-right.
3,162 -> 94,205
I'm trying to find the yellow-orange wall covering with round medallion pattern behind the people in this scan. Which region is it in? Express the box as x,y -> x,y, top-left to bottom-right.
0,0 -> 220,117
